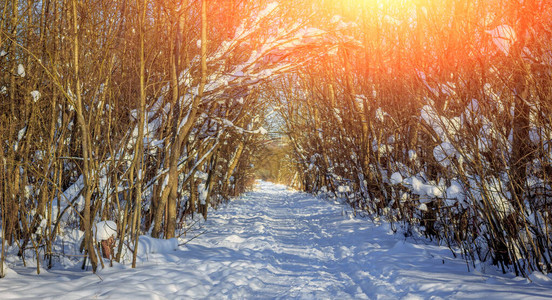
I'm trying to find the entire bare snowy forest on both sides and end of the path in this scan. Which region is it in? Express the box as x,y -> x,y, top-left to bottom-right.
0,0 -> 552,277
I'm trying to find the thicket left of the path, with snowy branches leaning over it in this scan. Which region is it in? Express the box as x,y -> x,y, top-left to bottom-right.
0,0 -> 340,275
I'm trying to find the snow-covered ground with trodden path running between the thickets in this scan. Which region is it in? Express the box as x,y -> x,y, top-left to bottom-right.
0,183 -> 552,299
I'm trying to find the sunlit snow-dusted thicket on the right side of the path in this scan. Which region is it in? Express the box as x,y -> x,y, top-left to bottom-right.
276,0 -> 552,274
